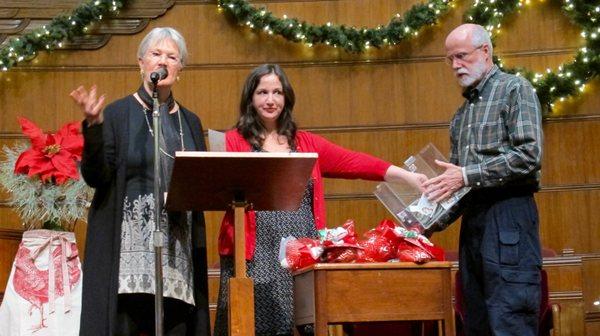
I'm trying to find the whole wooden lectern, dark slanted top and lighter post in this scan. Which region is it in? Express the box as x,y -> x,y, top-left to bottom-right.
166,152 -> 317,336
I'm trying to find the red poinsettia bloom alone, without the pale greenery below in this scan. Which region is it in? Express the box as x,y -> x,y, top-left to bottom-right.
15,118 -> 83,185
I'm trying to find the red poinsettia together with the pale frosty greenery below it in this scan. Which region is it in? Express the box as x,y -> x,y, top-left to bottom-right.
0,118 -> 91,230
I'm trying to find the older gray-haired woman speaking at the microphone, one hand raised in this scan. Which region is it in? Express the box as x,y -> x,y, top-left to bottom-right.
71,28 -> 210,336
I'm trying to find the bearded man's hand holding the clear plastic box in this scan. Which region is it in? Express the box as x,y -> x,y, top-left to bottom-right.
423,160 -> 465,202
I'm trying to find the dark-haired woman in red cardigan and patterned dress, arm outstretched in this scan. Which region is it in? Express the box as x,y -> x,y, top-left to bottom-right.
214,64 -> 427,336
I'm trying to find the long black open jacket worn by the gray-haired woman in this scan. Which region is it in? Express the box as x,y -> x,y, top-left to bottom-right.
80,95 -> 210,336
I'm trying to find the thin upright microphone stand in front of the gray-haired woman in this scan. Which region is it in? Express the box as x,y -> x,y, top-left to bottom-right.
151,78 -> 164,336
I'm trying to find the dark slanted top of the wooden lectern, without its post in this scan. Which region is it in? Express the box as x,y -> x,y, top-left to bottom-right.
166,152 -> 318,211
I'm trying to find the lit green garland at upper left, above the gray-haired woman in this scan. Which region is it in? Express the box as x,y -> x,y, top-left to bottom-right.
0,0 -> 126,71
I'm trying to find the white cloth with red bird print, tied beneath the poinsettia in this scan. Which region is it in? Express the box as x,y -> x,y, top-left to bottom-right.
0,230 -> 82,336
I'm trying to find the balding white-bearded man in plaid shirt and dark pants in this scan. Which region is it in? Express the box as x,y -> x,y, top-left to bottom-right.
424,24 -> 542,336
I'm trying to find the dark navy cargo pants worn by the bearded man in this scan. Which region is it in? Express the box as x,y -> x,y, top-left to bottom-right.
459,188 -> 542,336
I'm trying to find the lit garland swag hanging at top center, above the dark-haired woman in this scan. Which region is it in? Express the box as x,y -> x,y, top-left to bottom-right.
218,0 -> 453,52
